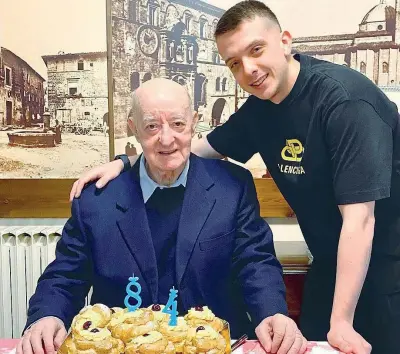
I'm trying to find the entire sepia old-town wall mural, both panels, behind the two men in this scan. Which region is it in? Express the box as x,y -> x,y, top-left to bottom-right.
0,0 -> 400,178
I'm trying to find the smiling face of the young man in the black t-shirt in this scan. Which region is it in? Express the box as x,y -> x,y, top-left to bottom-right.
216,17 -> 291,103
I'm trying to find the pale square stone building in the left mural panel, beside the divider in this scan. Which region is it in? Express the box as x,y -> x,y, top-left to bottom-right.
42,52 -> 108,134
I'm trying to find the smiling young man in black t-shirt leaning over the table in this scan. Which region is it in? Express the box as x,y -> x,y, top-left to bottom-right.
71,1 -> 400,354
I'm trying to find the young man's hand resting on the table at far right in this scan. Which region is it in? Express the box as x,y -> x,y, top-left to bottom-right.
328,321 -> 372,354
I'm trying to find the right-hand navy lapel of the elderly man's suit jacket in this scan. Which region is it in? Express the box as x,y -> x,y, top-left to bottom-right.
175,155 -> 215,286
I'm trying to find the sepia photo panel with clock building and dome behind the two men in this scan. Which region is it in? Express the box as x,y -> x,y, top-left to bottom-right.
111,0 -> 400,177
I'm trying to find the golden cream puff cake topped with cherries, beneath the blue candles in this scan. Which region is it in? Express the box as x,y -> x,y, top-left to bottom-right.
58,304 -> 230,354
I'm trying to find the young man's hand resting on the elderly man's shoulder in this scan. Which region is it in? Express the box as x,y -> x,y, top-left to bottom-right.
69,160 -> 124,202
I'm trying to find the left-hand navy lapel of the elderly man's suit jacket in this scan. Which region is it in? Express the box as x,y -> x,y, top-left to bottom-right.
117,160 -> 158,303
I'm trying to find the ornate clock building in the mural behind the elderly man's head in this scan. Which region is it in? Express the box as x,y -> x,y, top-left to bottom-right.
112,0 -> 252,138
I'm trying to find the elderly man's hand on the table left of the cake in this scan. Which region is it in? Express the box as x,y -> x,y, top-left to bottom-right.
16,317 -> 67,354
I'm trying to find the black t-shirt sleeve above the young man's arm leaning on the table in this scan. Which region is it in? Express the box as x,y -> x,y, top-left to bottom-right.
325,100 -> 393,205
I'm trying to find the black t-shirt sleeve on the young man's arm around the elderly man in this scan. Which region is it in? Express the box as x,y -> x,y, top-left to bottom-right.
207,100 -> 257,163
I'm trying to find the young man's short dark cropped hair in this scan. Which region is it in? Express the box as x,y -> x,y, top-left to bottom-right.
214,0 -> 282,38
